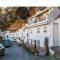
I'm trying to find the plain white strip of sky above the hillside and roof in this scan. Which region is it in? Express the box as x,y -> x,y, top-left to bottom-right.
0,0 -> 60,7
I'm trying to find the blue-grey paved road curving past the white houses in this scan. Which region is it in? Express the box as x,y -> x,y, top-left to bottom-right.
0,46 -> 55,60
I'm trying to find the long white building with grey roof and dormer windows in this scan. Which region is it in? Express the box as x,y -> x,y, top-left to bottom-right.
20,7 -> 60,47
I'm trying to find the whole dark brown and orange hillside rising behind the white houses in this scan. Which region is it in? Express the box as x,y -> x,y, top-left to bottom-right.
0,7 -> 46,31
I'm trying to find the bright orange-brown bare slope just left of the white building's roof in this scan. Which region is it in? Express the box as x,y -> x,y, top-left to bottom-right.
8,19 -> 26,32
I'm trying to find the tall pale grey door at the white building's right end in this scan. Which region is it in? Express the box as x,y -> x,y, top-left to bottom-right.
53,23 -> 59,46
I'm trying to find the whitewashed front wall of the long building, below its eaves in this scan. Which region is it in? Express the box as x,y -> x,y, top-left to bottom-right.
25,24 -> 53,47
